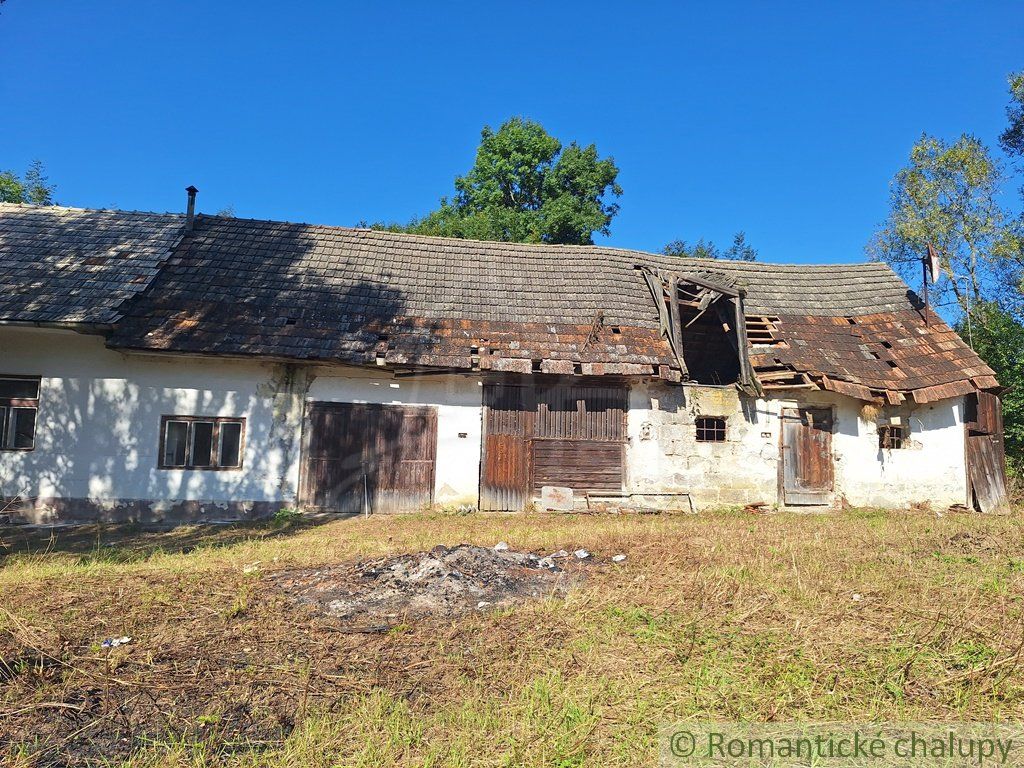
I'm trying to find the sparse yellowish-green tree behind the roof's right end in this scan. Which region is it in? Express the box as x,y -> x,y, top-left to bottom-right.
868,134 -> 1020,311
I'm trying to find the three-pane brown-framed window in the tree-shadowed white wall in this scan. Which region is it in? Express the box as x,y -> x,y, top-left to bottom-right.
158,416 -> 246,470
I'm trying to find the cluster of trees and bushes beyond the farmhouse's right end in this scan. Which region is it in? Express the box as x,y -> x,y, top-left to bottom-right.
868,73 -> 1024,474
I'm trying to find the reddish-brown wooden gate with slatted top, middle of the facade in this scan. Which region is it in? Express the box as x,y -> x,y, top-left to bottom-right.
480,382 -> 627,511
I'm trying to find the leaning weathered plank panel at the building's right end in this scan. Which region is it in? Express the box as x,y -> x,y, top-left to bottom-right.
964,392 -> 1010,512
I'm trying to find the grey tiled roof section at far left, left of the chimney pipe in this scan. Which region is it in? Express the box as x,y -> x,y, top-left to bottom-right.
0,203 -> 184,325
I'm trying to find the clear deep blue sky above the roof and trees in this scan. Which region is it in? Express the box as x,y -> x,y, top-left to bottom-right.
0,0 -> 1024,262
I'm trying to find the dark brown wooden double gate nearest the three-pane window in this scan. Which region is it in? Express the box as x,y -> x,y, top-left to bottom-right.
299,402 -> 437,513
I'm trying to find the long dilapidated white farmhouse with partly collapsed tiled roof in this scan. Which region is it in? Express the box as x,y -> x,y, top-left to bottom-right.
0,190 -> 1006,522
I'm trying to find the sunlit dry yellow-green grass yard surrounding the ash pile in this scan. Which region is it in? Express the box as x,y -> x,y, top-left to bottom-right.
0,510 -> 1024,767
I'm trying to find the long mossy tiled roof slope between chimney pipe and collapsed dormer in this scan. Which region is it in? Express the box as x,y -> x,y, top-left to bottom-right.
110,215 -> 679,380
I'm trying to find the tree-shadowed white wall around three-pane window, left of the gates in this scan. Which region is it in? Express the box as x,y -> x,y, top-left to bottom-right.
0,327 -> 297,524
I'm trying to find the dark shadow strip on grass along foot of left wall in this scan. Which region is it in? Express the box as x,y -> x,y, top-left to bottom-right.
0,515 -> 344,567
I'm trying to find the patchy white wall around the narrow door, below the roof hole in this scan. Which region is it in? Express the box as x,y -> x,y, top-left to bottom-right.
627,383 -> 967,508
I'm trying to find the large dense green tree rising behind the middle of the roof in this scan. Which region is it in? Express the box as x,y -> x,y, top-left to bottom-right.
375,118 -> 623,245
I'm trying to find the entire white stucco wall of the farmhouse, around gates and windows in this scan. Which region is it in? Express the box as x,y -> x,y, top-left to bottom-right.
0,327 -> 967,521
